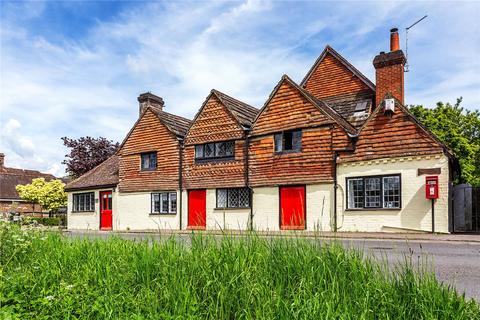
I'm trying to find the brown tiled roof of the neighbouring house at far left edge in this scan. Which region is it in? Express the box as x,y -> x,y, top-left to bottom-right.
0,167 -> 55,200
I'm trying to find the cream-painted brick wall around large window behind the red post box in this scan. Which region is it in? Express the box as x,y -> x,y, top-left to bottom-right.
337,155 -> 449,233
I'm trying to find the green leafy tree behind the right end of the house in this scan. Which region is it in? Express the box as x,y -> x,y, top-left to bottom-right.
409,98 -> 480,186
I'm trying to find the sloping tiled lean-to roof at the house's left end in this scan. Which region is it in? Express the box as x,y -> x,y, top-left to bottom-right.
65,155 -> 119,191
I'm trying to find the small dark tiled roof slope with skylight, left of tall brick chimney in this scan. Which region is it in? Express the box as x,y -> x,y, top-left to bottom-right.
322,91 -> 374,129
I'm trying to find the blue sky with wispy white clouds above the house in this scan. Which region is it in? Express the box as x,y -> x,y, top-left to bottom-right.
0,1 -> 480,175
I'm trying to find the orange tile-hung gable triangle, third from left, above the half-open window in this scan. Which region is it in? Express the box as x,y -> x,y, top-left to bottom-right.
252,78 -> 333,135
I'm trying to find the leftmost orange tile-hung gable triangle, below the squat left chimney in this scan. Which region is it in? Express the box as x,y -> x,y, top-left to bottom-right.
119,109 -> 178,156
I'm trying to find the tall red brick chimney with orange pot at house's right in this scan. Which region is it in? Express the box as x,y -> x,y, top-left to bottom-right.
373,28 -> 407,106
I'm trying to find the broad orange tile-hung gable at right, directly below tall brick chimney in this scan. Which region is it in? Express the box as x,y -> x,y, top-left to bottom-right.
341,101 -> 444,162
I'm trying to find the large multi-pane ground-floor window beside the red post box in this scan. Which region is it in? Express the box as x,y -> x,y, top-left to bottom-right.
347,175 -> 401,209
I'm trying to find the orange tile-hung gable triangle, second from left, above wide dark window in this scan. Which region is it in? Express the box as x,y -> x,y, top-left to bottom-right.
185,93 -> 244,145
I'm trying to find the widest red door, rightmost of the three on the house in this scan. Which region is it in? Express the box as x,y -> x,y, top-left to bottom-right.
280,186 -> 306,230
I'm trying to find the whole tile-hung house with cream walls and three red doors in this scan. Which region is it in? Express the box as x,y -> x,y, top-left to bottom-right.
66,29 -> 459,233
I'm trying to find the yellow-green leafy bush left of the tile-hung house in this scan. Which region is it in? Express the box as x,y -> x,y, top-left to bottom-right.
16,178 -> 67,212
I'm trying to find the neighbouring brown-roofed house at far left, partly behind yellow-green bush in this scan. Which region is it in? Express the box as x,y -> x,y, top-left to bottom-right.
0,153 -> 55,216
